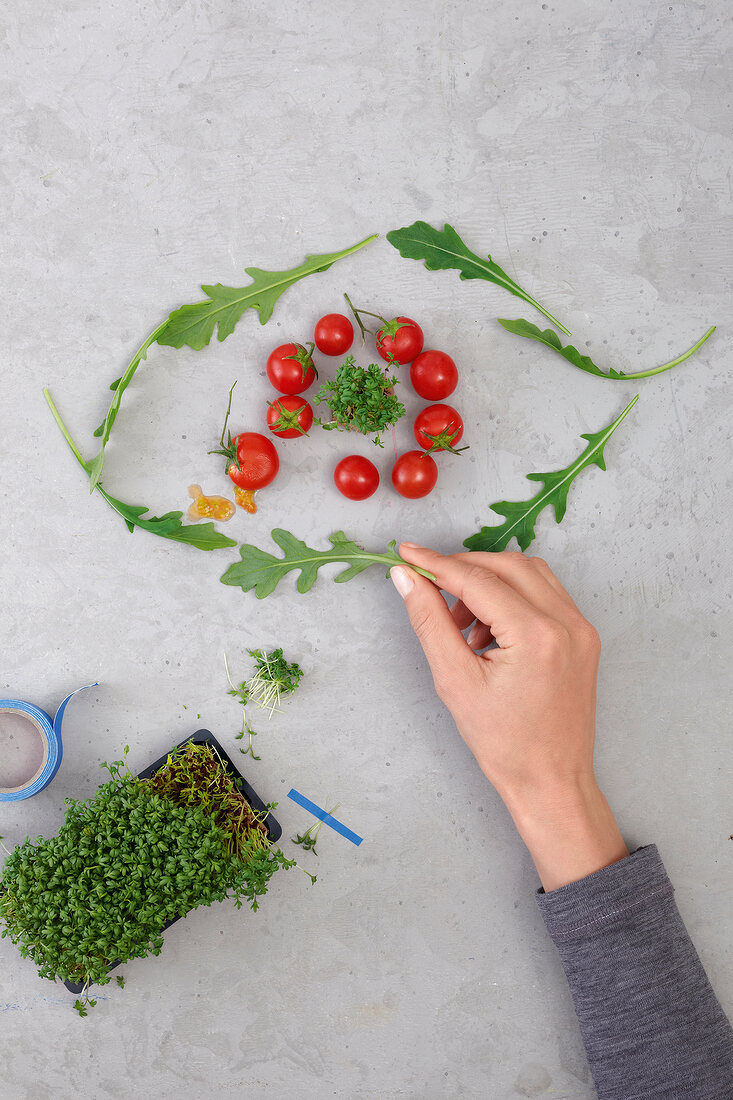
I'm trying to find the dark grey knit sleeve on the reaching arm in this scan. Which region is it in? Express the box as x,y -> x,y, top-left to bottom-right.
537,845 -> 733,1100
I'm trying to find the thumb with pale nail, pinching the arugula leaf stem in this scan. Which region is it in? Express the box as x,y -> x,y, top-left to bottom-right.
390,565 -> 473,703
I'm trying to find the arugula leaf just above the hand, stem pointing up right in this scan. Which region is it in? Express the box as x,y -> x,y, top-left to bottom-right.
463,394 -> 638,551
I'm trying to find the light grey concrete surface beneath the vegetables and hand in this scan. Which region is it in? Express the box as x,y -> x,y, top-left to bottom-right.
0,0 -> 733,1100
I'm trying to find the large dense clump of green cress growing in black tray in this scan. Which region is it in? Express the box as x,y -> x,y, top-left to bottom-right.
0,746 -> 294,1015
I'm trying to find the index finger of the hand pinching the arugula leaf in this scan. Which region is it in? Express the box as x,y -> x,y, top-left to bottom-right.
400,542 -> 539,649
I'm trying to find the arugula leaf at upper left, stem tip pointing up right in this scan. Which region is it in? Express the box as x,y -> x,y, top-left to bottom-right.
157,233 -> 378,351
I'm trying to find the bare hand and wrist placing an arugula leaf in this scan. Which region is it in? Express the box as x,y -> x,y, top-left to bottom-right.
391,542 -> 628,890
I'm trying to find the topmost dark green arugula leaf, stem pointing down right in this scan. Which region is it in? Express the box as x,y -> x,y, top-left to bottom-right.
387,221 -> 570,336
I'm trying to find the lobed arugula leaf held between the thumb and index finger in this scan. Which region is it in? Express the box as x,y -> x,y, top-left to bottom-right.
221,527 -> 435,600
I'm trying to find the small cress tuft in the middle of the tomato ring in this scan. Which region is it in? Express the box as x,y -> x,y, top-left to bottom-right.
314,355 -> 405,447
